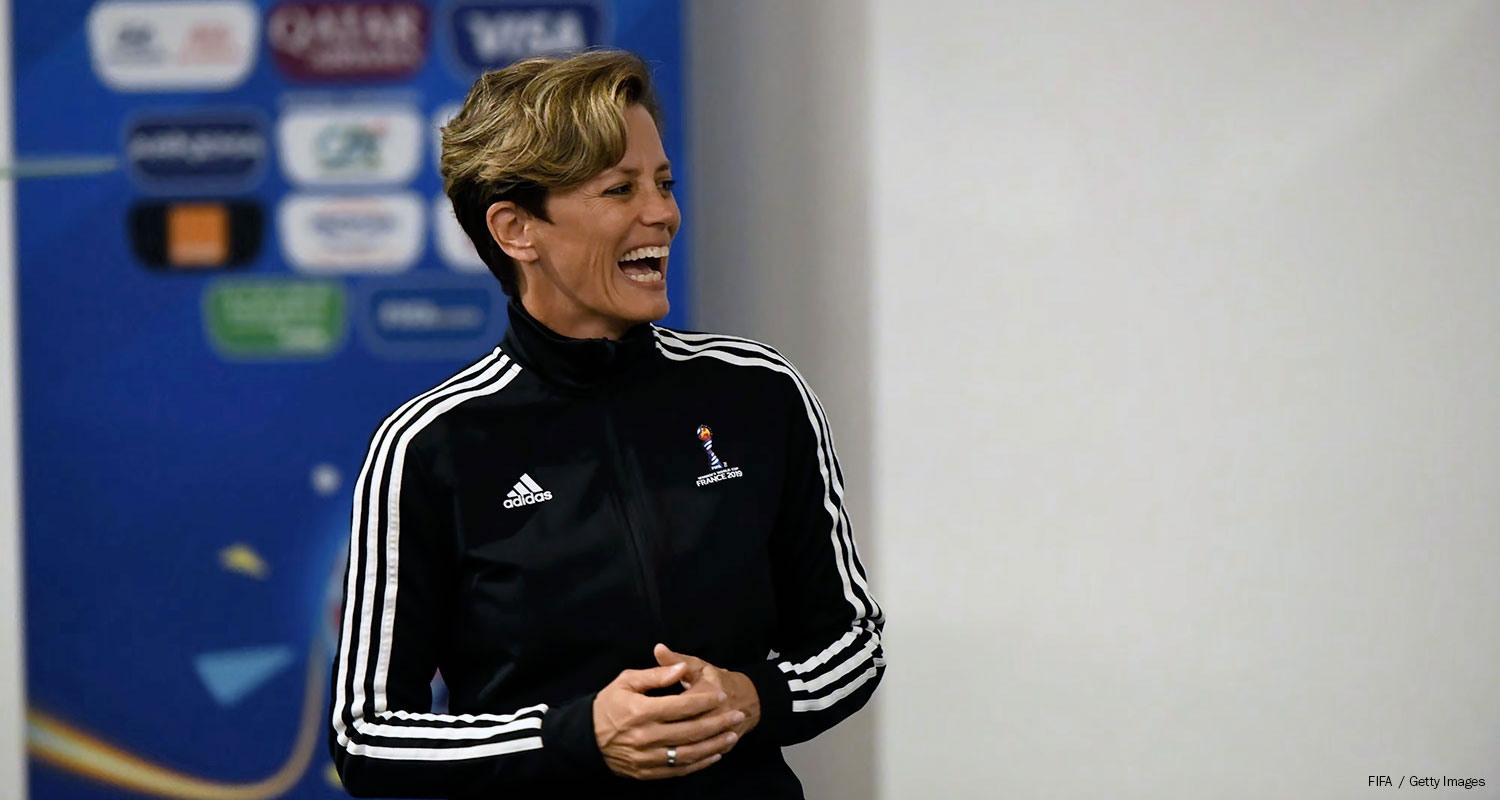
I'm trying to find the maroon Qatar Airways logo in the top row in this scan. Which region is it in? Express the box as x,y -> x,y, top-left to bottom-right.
266,2 -> 428,81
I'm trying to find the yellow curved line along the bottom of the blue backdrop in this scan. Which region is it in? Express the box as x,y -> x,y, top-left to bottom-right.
27,647 -> 327,800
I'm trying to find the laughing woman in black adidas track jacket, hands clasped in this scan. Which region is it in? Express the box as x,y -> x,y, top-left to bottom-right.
330,51 -> 885,798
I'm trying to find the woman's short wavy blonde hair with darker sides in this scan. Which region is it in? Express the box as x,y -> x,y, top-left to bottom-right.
440,50 -> 662,296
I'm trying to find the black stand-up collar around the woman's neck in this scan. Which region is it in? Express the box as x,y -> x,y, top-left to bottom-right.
501,299 -> 656,390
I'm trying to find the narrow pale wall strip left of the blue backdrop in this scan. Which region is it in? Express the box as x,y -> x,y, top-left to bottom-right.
0,0 -> 26,797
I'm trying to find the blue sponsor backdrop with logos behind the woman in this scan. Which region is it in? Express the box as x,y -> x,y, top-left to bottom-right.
12,0 -> 689,800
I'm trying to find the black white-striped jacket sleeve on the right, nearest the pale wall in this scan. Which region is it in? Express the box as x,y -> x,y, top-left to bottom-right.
740,365 -> 885,746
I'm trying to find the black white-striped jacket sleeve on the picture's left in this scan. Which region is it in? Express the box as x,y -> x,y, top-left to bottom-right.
329,422 -> 609,798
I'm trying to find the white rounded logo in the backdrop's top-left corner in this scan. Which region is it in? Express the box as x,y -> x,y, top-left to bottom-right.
87,0 -> 260,92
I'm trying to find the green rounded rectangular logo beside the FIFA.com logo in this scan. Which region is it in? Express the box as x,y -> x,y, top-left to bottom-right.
203,281 -> 347,359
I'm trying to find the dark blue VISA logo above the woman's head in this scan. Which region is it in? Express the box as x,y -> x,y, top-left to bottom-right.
450,2 -> 603,72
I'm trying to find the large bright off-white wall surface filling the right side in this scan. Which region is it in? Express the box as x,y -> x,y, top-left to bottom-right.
876,0 -> 1500,798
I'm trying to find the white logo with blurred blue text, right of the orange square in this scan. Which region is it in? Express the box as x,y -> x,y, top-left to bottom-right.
276,192 -> 428,273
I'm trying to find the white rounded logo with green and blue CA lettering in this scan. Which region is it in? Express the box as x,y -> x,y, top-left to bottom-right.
276,105 -> 426,186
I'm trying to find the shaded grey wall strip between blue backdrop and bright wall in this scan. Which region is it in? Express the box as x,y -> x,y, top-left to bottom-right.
690,0 -> 879,800
